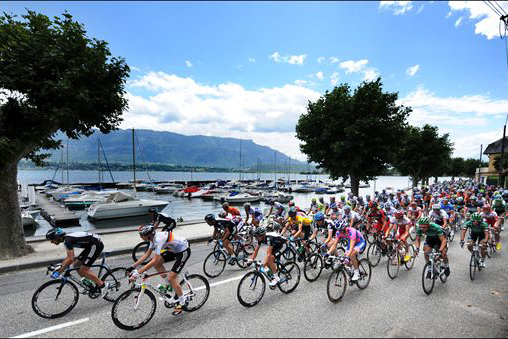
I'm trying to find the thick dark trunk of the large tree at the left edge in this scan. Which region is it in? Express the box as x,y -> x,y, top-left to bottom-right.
0,163 -> 33,259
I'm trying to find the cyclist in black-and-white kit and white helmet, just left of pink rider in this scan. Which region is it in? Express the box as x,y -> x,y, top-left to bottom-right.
247,227 -> 287,286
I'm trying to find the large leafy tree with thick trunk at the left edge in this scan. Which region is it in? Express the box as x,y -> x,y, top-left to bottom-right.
0,11 -> 130,258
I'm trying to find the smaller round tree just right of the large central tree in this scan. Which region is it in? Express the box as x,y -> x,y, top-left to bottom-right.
394,124 -> 453,187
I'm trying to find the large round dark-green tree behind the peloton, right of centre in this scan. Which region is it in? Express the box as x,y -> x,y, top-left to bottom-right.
296,78 -> 411,195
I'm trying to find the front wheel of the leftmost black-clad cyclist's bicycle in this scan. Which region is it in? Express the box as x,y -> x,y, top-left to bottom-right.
32,279 -> 79,319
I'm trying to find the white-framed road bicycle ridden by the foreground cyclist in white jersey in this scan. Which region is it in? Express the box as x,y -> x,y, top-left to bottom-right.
111,272 -> 210,331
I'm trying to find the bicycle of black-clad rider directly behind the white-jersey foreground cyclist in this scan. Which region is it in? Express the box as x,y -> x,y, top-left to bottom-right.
203,240 -> 254,278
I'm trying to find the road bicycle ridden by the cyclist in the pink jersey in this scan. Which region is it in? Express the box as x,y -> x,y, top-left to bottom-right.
326,256 -> 372,304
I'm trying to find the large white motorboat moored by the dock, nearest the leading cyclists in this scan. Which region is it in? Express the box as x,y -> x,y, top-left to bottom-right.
87,192 -> 169,220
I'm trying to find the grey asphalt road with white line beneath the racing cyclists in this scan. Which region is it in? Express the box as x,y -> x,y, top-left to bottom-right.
0,233 -> 508,338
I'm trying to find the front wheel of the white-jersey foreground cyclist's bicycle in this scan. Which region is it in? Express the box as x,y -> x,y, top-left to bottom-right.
111,287 -> 157,331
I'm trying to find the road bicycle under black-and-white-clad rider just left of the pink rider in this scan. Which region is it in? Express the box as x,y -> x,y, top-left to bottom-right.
236,256 -> 300,307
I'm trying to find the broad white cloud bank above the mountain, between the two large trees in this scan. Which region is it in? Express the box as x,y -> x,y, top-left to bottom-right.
121,72 -> 321,160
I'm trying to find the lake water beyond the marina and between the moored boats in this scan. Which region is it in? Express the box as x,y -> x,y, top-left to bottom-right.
18,170 -> 449,236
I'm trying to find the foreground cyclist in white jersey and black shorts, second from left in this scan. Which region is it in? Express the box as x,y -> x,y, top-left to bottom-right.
127,225 -> 191,315
